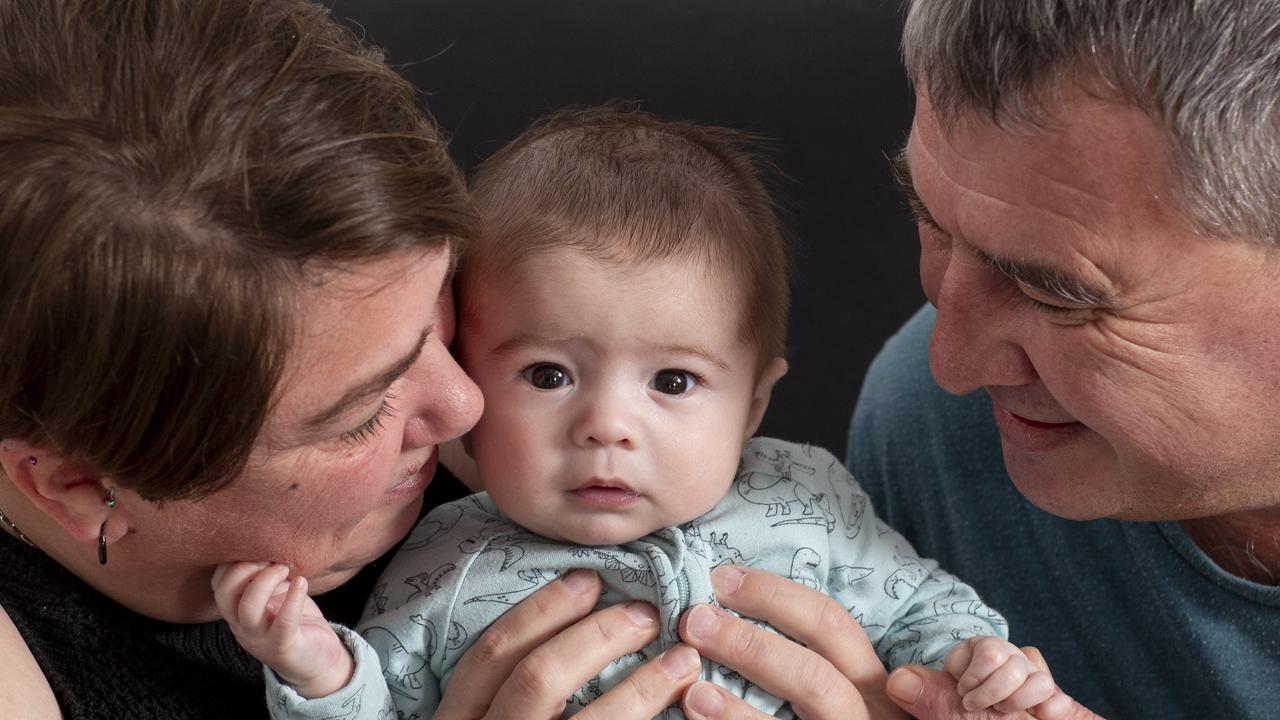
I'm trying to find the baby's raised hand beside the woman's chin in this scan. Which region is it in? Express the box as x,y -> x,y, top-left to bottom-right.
212,562 -> 356,698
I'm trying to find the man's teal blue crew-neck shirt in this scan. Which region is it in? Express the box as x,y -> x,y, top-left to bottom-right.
847,306 -> 1280,720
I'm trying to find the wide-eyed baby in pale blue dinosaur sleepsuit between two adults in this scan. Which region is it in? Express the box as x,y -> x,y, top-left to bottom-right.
214,108 -> 1056,717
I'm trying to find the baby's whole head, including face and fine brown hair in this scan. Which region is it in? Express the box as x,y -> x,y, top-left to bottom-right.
458,108 -> 788,544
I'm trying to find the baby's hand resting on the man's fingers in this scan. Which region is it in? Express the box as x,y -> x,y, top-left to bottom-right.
943,635 -> 1071,720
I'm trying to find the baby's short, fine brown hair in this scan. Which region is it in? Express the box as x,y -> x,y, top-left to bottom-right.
460,104 -> 790,368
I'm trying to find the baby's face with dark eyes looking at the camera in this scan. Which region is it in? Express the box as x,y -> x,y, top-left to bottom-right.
460,252 -> 781,544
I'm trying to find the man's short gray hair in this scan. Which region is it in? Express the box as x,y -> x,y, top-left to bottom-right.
902,0 -> 1280,245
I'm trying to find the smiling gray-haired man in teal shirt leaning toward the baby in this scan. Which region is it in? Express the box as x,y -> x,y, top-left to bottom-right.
849,0 -> 1280,719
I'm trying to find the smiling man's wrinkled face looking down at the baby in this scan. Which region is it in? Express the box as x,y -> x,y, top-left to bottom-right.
906,91 -> 1280,519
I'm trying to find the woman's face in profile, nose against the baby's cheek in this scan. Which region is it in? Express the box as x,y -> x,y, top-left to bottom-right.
108,250 -> 481,620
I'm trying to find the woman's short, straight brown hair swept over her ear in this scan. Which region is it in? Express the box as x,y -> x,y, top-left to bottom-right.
0,0 -> 472,500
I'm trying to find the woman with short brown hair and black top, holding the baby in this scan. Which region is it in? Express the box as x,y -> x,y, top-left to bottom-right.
0,0 -> 883,717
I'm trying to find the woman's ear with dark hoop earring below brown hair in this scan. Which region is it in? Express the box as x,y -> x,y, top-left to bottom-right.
0,439 -> 123,544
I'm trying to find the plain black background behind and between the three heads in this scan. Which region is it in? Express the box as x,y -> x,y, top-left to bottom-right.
325,0 -> 924,455
